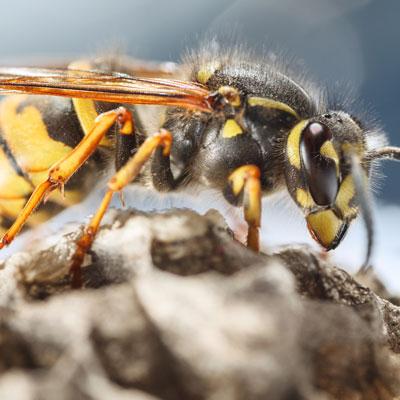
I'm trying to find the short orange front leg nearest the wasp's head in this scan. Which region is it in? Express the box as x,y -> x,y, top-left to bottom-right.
228,165 -> 262,251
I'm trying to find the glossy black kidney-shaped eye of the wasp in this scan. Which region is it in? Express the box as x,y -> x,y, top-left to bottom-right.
300,122 -> 339,206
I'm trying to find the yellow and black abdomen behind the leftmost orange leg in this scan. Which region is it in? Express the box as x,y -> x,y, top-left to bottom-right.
0,68 -> 119,231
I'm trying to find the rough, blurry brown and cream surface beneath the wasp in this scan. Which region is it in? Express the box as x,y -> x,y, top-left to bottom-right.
0,211 -> 400,400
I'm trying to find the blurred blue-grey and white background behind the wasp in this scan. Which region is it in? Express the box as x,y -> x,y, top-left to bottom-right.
0,0 -> 400,290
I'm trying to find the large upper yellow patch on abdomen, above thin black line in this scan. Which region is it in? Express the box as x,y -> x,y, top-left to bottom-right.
0,96 -> 71,173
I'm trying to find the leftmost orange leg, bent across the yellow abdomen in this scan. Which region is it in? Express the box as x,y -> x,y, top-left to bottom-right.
0,107 -> 132,249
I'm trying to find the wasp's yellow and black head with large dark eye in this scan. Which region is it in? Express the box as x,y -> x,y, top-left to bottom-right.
285,112 -> 369,250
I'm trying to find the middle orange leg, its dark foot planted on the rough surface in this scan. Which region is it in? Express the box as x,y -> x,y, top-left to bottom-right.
71,129 -> 172,287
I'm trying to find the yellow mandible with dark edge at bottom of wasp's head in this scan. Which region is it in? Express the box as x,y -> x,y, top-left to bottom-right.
306,210 -> 343,248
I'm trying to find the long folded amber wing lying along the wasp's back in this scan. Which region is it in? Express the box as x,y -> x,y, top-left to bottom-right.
0,68 -> 210,111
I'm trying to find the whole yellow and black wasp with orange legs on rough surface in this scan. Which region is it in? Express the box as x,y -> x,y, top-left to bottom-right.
0,46 -> 400,285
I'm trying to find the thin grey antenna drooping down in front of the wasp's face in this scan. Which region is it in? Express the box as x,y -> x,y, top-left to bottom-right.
350,153 -> 376,273
